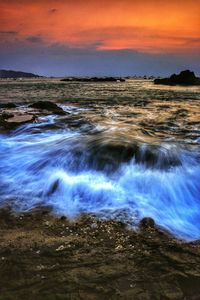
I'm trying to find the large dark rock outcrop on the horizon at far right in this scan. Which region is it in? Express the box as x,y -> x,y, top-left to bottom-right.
154,70 -> 200,85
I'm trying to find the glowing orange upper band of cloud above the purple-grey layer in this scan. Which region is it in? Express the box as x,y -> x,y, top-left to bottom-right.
0,0 -> 200,53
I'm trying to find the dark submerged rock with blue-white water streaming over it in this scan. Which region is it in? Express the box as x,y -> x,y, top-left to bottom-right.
83,138 -> 181,172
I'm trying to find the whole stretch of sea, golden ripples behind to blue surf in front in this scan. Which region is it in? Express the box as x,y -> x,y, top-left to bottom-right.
0,81 -> 200,240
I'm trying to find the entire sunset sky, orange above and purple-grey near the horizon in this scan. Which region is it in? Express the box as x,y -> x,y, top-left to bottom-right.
0,0 -> 200,76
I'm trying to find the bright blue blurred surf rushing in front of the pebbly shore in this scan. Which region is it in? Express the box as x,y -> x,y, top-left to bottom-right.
0,112 -> 200,239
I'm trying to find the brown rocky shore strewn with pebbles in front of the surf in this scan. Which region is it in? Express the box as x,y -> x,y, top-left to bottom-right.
0,207 -> 200,300
